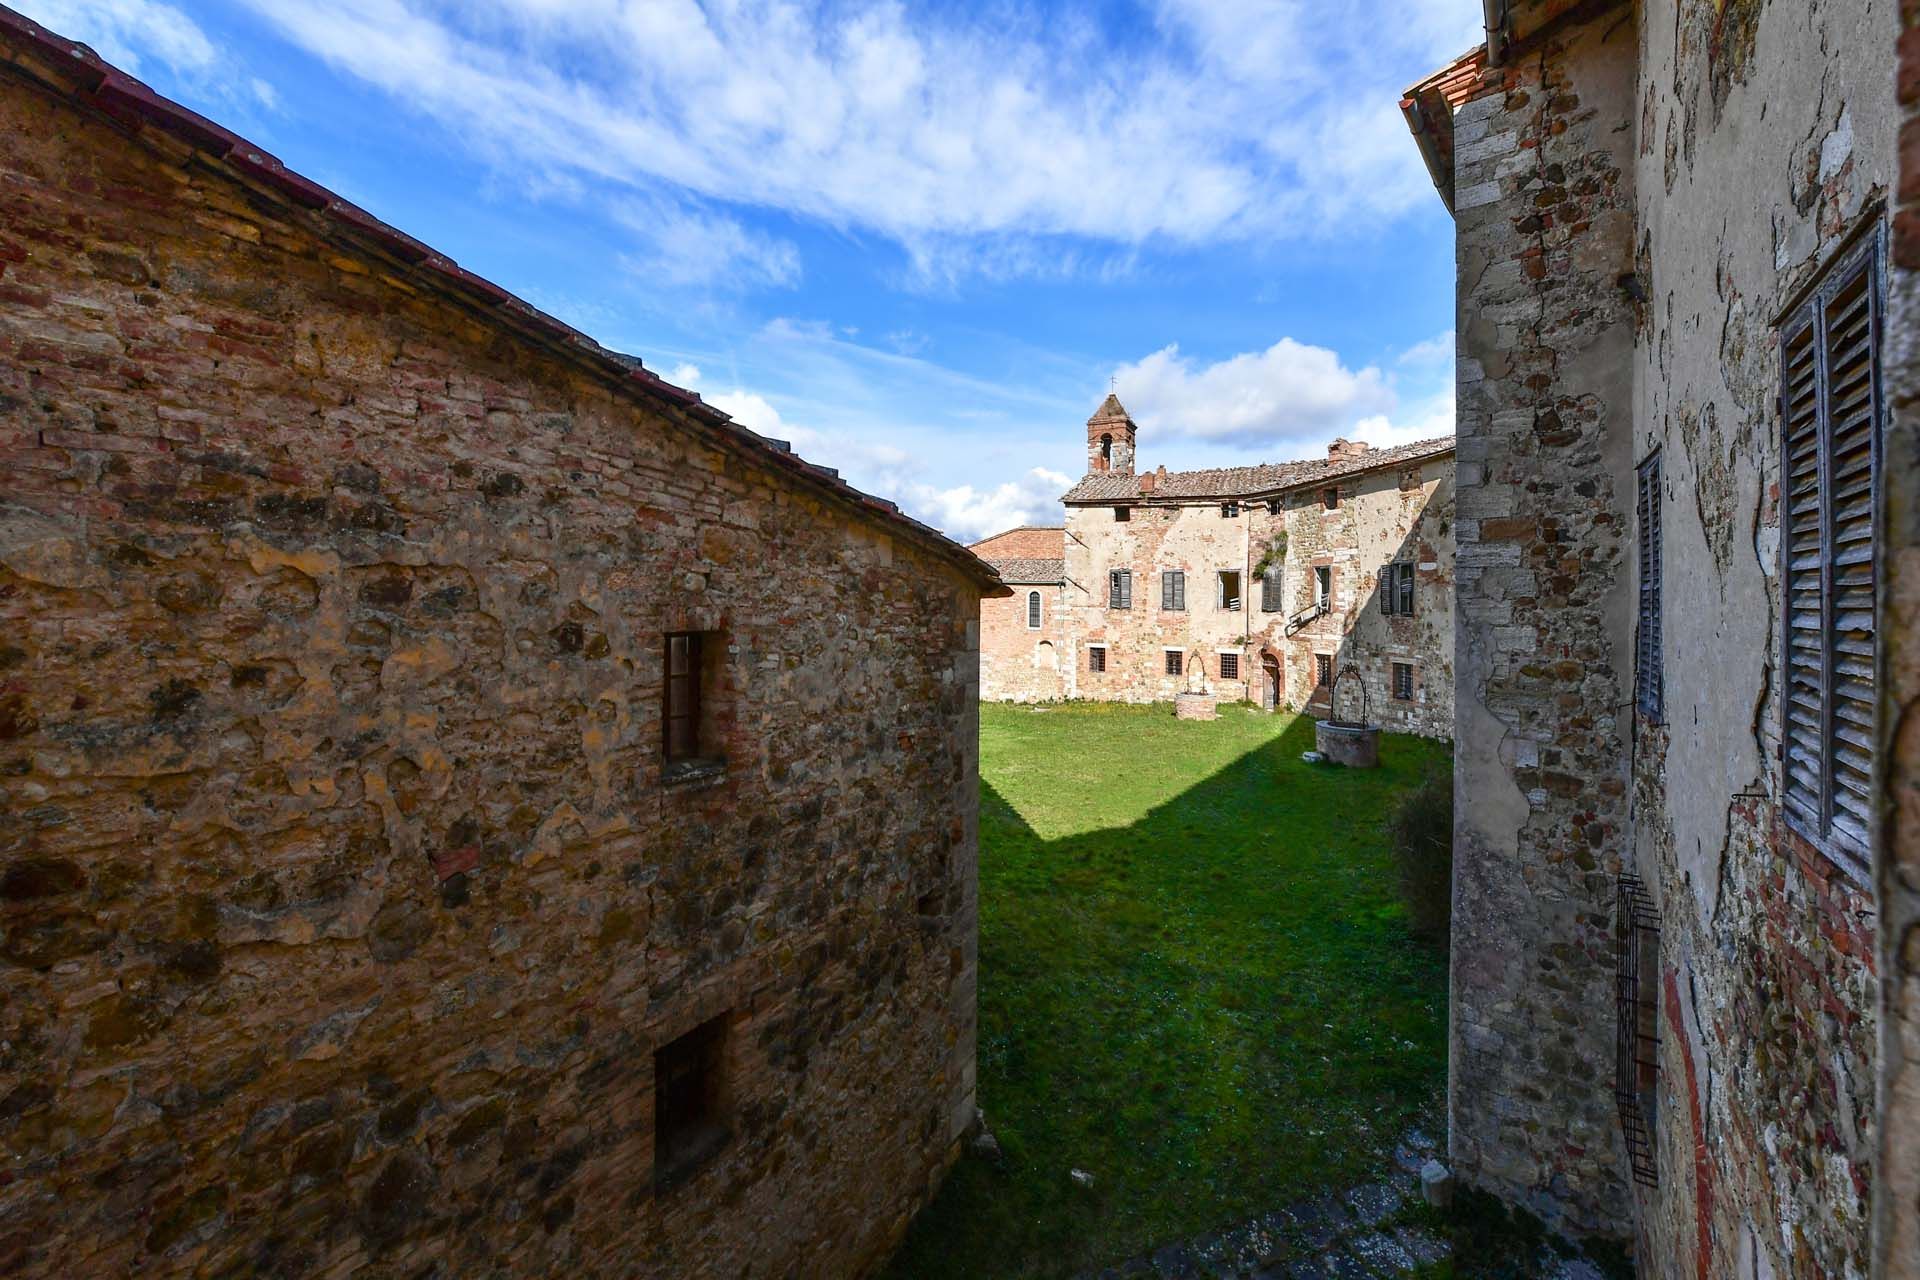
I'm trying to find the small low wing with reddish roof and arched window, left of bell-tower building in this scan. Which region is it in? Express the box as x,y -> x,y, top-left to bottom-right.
970,526 -> 1069,702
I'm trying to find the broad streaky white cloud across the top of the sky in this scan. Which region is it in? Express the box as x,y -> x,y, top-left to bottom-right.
220,0 -> 1475,284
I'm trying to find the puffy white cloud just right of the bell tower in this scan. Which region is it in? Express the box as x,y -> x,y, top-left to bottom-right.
1114,338 -> 1394,447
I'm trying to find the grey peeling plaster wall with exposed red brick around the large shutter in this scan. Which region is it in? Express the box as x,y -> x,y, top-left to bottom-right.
1622,0 -> 1895,1278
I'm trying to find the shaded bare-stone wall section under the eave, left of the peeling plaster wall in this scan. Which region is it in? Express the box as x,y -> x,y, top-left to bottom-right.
1450,12 -> 1636,1234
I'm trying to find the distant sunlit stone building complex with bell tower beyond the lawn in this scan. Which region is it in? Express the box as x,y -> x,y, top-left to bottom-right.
975,395 -> 1453,737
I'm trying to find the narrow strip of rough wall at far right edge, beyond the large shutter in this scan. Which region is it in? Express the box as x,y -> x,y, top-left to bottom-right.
1866,0 -> 1920,1280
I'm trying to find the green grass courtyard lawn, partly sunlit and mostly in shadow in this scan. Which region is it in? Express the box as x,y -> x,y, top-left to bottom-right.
889,704 -> 1450,1280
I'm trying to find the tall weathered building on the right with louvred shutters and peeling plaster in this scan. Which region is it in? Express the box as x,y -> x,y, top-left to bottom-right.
1402,0 -> 1920,1280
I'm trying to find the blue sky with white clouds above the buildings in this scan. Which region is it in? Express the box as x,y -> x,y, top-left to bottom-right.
22,0 -> 1480,539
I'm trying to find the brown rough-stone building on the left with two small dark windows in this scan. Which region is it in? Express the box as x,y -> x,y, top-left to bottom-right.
0,10 -> 1004,1278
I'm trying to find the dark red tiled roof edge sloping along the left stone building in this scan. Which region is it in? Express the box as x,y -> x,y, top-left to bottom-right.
0,4 -> 1010,595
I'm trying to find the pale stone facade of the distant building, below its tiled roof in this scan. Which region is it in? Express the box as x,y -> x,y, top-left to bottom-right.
1066,457 -> 1453,737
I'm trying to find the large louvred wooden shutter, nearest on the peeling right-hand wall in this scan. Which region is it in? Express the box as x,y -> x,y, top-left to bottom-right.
1780,230 -> 1885,885
